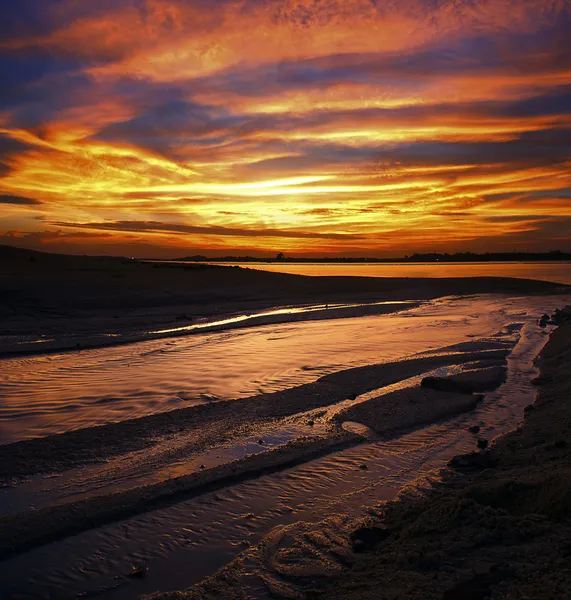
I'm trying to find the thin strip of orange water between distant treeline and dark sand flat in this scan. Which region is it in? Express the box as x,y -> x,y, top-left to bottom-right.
213,262 -> 571,285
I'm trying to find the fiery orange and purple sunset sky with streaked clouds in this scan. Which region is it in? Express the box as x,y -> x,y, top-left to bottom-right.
0,0 -> 571,257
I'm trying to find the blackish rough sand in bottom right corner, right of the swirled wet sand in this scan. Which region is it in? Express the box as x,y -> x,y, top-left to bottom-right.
308,324 -> 571,600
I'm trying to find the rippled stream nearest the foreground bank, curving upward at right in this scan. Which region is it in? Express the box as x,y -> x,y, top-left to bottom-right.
0,310 -> 560,600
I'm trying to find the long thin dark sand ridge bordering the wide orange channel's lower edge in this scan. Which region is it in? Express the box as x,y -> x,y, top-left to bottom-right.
0,350 -> 508,481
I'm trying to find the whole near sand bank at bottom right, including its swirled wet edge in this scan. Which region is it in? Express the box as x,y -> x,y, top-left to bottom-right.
144,324 -> 571,600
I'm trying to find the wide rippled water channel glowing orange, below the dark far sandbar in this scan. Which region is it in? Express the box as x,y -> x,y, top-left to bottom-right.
0,296 -> 569,443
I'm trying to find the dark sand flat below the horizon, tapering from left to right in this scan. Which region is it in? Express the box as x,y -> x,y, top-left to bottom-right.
0,246 -> 569,356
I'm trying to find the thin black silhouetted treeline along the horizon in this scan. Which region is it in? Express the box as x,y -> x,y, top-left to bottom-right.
175,250 -> 571,263
